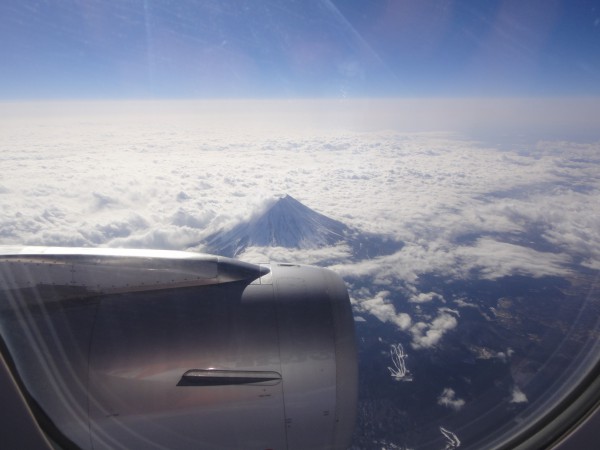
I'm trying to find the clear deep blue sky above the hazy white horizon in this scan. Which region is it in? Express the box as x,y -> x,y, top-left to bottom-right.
0,0 -> 600,100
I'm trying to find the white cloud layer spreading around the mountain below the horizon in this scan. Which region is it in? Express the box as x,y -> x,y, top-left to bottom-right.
0,102 -> 600,349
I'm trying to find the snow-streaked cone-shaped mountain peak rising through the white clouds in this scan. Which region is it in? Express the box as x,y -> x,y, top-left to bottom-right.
204,195 -> 403,259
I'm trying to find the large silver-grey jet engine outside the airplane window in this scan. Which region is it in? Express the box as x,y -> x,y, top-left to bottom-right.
0,247 -> 357,450
